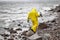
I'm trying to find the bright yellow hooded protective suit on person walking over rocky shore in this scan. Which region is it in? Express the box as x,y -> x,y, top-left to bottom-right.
28,8 -> 40,32
